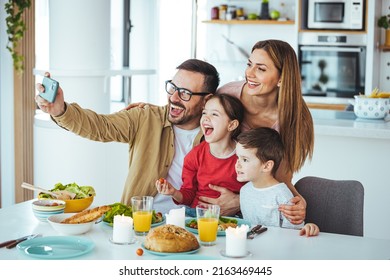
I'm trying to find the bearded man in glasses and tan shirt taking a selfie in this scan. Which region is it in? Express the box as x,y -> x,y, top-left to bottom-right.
35,59 -> 239,212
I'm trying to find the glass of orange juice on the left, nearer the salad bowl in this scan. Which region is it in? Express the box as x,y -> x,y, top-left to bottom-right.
131,196 -> 153,236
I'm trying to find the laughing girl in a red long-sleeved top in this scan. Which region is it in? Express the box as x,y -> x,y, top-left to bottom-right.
156,94 -> 244,211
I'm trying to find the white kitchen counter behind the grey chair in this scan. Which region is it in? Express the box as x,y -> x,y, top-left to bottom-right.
293,110 -> 390,239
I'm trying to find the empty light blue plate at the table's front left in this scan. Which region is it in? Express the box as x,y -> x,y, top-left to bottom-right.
17,236 -> 95,259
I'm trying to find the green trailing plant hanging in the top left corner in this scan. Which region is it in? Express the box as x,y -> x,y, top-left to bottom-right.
4,0 -> 31,72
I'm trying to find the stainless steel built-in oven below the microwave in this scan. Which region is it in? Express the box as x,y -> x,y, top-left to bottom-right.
298,32 -> 367,97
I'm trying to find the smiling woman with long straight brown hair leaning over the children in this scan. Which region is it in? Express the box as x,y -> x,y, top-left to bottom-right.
201,40 -> 314,223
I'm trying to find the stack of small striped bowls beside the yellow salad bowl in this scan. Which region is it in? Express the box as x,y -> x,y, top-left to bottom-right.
32,199 -> 66,222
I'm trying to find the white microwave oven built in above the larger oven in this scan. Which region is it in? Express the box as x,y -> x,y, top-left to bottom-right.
307,0 -> 364,30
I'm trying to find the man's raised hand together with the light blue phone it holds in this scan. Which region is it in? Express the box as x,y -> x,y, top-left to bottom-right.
35,72 -> 65,117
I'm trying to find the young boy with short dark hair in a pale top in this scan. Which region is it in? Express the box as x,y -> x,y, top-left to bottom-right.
236,127 -> 319,236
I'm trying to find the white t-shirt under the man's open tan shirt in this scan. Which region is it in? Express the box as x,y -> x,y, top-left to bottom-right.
153,125 -> 200,213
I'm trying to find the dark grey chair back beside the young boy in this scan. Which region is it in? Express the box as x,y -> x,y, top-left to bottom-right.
295,176 -> 364,236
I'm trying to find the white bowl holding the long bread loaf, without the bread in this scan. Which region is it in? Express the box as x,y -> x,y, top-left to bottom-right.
47,213 -> 95,235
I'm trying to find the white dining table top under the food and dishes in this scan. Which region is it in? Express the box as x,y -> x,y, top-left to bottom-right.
0,199 -> 390,260
